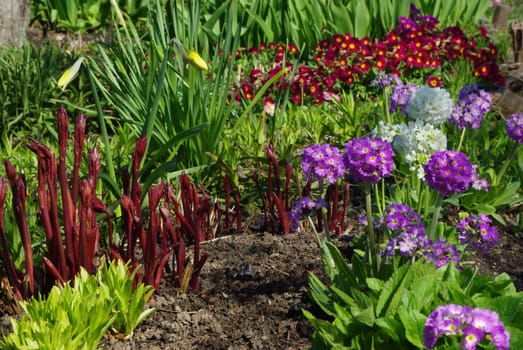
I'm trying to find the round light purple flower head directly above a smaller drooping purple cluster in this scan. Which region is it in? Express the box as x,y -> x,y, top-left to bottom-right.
301,144 -> 345,184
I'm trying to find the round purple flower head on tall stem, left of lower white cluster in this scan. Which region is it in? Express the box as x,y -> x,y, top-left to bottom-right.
343,137 -> 394,183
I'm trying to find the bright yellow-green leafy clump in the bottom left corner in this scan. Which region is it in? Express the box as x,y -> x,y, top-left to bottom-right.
0,263 -> 154,350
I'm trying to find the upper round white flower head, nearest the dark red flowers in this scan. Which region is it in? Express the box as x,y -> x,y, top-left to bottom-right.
407,85 -> 454,126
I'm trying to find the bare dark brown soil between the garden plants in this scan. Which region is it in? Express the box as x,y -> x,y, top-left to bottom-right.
97,226 -> 523,350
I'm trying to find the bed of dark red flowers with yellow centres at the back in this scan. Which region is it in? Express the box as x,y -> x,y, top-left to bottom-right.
230,9 -> 504,110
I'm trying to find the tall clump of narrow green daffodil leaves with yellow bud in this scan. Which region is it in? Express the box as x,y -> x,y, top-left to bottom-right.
89,0 -> 237,193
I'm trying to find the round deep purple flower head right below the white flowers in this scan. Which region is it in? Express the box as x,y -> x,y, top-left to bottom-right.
423,150 -> 477,196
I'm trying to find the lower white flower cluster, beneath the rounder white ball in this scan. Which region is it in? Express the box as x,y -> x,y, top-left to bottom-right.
372,121 -> 447,178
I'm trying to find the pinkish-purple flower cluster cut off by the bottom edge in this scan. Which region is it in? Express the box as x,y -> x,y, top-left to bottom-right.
423,304 -> 510,350
